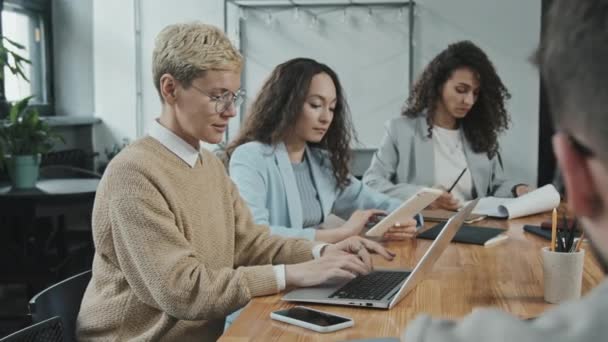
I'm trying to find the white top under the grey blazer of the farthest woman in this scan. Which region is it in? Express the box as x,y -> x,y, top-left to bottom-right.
432,126 -> 473,203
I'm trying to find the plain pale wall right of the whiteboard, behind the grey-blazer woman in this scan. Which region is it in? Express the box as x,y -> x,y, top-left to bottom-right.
415,0 -> 541,184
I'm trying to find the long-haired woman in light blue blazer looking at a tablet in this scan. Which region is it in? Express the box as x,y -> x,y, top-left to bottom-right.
226,58 -> 417,242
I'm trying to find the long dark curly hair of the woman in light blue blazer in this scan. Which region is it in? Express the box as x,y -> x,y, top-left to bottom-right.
225,58 -> 355,189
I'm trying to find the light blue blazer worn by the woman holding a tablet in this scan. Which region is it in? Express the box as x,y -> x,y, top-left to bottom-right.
229,142 -> 420,240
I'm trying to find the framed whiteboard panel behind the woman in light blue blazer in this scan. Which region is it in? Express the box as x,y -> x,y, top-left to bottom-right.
235,7 -> 409,147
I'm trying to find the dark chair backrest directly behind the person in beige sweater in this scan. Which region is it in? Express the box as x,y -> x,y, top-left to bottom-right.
30,270 -> 91,342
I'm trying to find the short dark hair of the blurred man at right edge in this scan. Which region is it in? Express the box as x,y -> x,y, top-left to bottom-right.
536,0 -> 608,161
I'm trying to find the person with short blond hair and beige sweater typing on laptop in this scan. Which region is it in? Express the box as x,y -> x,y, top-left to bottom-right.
77,23 -> 392,341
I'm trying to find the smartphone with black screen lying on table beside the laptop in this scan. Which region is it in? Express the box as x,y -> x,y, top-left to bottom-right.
270,306 -> 355,333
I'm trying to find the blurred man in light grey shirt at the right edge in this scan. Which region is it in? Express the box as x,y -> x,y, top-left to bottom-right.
402,0 -> 608,342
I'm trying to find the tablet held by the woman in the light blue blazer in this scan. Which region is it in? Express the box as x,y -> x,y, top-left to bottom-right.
365,188 -> 443,237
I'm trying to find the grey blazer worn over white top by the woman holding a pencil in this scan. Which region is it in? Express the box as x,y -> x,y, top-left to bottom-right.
363,115 -> 521,199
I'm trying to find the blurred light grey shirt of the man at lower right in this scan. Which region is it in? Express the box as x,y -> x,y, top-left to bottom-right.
401,280 -> 608,342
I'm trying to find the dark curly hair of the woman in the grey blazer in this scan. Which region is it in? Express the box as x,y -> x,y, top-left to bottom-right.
401,41 -> 511,158
